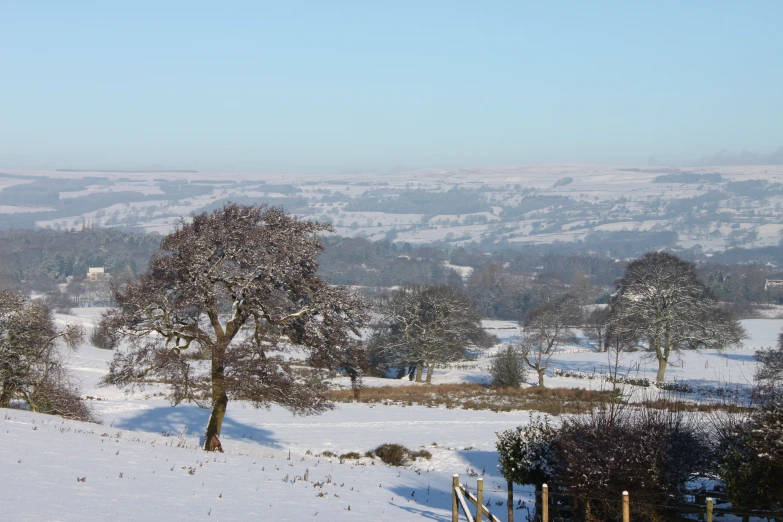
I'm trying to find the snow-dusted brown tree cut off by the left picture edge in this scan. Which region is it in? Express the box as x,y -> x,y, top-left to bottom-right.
0,289 -> 93,421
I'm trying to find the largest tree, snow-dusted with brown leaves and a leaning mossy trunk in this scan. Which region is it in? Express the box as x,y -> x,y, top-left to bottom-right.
103,204 -> 364,451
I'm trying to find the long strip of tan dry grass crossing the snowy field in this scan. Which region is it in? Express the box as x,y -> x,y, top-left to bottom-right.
329,384 -> 611,415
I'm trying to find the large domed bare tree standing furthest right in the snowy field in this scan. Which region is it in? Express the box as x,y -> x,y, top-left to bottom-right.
609,252 -> 745,381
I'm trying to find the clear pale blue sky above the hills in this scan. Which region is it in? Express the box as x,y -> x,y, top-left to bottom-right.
0,0 -> 783,173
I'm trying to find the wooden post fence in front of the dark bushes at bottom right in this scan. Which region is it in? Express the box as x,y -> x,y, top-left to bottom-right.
451,475 -> 783,522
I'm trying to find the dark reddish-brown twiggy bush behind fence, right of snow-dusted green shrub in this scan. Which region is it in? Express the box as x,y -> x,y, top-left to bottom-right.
553,404 -> 708,520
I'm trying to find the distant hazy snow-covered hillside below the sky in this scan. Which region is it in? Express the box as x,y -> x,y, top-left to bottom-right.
6,165 -> 783,251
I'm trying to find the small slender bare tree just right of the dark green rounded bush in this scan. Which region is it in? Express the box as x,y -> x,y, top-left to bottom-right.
517,294 -> 582,387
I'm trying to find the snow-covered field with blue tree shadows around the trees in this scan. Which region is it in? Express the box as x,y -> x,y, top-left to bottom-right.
0,308 -> 783,521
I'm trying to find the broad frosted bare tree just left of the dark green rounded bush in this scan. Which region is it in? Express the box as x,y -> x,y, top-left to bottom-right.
369,285 -> 495,383
